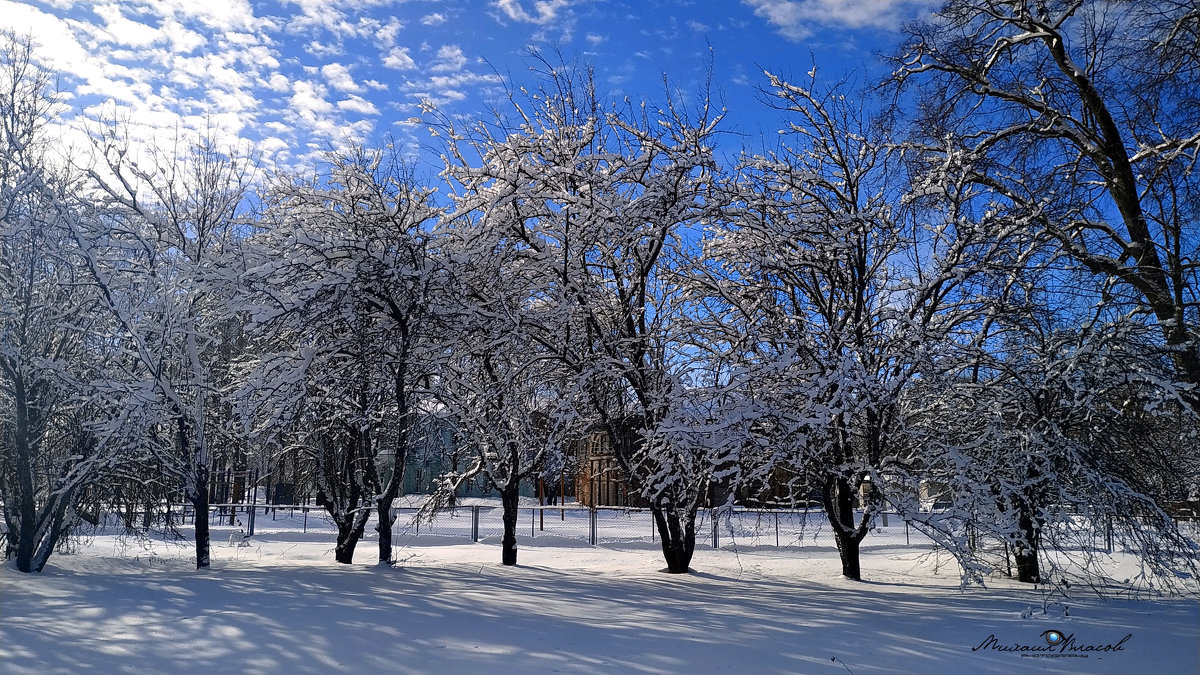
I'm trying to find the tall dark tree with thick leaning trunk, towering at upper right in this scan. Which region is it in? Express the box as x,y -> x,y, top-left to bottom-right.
894,0 -> 1200,396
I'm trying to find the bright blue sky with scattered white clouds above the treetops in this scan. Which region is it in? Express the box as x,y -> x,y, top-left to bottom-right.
7,0 -> 932,168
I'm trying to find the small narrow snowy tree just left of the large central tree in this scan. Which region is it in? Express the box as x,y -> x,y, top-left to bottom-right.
427,201 -> 584,565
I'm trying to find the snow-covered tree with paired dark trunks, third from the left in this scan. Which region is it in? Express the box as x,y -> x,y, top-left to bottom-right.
240,149 -> 445,563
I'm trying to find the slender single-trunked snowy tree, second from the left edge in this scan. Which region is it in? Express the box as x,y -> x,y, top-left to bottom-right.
72,124 -> 256,568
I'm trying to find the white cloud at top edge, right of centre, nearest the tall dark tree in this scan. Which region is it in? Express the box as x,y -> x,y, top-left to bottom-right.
742,0 -> 936,40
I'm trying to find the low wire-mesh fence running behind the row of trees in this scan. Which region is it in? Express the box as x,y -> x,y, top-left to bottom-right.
65,503 -> 1200,568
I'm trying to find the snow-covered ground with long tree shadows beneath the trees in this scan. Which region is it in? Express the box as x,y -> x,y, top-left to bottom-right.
0,511 -> 1200,675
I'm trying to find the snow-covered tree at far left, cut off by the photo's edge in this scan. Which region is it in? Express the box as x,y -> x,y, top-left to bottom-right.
0,32 -> 130,572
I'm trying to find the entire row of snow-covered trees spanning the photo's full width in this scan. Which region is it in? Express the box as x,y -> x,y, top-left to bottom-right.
0,0 -> 1200,585
